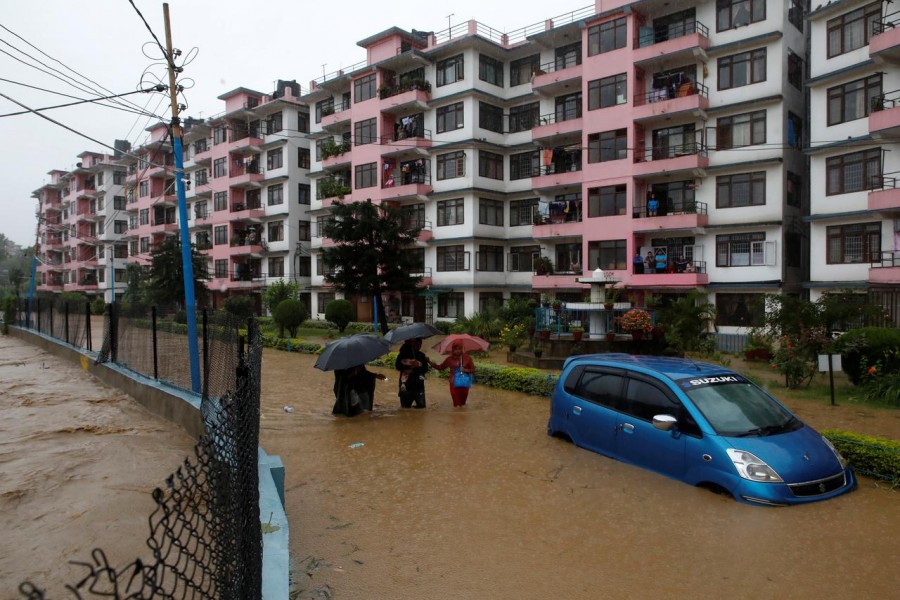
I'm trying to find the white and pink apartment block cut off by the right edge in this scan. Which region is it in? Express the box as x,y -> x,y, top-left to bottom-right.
808,0 -> 900,324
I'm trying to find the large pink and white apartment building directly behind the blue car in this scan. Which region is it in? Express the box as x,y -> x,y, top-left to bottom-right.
303,0 -> 810,331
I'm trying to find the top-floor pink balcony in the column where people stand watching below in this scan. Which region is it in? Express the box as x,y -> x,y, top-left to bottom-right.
632,21 -> 710,66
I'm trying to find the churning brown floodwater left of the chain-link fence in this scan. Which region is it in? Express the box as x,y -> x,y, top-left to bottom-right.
0,336 -> 194,598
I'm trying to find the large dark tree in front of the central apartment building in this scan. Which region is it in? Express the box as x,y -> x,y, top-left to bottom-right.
322,201 -> 422,333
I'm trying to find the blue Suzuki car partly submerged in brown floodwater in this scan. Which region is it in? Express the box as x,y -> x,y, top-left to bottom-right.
547,354 -> 856,506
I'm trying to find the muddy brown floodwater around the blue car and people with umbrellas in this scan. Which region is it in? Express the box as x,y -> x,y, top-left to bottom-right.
261,350 -> 900,600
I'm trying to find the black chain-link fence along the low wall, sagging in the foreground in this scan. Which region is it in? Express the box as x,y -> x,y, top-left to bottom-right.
12,304 -> 262,600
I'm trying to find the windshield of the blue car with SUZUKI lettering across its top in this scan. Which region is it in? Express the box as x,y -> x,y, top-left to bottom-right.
679,376 -> 803,437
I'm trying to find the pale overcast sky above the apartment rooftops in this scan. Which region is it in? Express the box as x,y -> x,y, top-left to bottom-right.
0,0 -> 576,246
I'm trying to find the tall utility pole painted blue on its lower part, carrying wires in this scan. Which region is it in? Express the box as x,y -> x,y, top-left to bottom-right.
163,2 -> 201,393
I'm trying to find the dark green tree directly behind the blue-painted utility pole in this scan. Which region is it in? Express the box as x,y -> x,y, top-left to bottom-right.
146,236 -> 209,308
